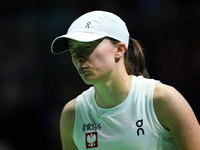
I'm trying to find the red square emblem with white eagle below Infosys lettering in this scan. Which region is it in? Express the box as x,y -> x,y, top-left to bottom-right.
85,132 -> 98,149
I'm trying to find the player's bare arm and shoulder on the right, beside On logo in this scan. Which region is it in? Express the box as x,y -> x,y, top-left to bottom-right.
153,83 -> 200,150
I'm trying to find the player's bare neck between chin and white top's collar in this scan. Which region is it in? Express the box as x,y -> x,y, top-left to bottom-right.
94,74 -> 132,108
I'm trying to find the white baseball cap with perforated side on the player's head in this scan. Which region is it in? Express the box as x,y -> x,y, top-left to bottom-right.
51,11 -> 129,54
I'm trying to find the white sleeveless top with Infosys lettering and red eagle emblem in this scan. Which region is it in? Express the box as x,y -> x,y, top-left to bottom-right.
73,76 -> 178,150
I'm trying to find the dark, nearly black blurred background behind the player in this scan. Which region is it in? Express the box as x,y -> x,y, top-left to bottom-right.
0,0 -> 200,150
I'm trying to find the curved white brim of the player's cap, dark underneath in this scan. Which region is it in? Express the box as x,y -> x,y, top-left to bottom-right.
51,32 -> 105,54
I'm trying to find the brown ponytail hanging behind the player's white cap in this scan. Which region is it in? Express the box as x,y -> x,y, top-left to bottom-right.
124,38 -> 149,78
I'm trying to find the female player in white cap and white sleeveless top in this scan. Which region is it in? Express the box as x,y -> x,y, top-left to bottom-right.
51,11 -> 200,150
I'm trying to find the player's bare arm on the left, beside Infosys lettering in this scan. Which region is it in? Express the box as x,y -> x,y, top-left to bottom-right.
60,99 -> 77,150
